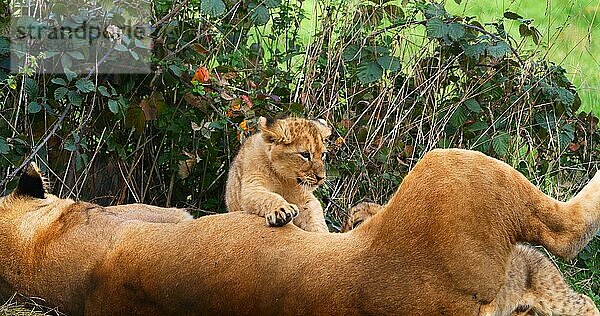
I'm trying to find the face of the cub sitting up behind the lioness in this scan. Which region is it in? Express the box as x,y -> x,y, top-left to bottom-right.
259,118 -> 331,190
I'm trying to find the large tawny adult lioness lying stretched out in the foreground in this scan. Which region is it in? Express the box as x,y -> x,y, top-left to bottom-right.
0,150 -> 600,315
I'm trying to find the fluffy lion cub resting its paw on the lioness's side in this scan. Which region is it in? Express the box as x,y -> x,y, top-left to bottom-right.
225,117 -> 331,232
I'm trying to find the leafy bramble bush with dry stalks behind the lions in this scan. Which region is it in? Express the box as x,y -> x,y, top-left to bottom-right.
0,0 -> 600,306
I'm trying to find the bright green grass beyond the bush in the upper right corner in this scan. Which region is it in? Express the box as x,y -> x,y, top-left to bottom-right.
446,0 -> 600,115
